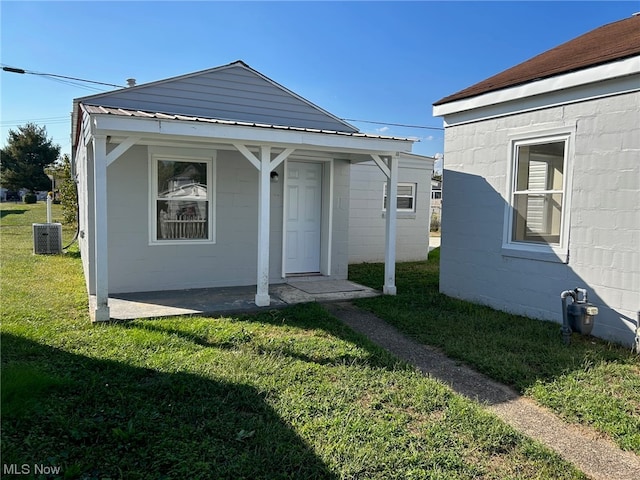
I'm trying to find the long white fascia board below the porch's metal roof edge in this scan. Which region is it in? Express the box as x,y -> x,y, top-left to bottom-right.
91,114 -> 413,153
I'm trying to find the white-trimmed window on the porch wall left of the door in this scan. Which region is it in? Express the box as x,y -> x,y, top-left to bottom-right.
150,154 -> 214,244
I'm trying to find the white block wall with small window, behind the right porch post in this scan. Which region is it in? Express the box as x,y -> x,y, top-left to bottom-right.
349,161 -> 433,263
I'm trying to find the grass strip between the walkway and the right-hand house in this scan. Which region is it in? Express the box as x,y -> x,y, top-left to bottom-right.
349,249 -> 640,455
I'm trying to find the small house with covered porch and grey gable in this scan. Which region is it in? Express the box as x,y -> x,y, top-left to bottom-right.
72,61 -> 432,320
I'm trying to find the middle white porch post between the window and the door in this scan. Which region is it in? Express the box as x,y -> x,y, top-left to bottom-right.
255,145 -> 271,307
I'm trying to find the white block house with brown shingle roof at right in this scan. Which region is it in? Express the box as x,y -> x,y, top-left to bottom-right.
433,16 -> 640,344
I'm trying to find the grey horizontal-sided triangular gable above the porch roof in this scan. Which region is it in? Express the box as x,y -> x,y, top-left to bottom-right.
74,61 -> 358,133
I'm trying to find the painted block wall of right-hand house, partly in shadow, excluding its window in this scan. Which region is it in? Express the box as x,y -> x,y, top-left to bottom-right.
440,93 -> 640,344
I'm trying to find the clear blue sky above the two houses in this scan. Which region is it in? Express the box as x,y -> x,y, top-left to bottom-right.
0,0 -> 640,161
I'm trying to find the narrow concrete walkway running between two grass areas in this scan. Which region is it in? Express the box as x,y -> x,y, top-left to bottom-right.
326,302 -> 640,480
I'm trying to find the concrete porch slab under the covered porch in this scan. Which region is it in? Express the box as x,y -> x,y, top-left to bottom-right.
102,277 -> 381,320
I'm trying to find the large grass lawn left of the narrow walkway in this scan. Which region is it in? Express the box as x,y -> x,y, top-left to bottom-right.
0,204 -> 585,480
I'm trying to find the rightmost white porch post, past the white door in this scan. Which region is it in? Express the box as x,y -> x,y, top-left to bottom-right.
382,155 -> 398,295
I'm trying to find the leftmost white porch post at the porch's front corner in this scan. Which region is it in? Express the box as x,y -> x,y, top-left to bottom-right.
91,135 -> 110,322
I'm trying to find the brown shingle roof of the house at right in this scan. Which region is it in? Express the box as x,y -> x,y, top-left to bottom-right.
433,15 -> 640,106
